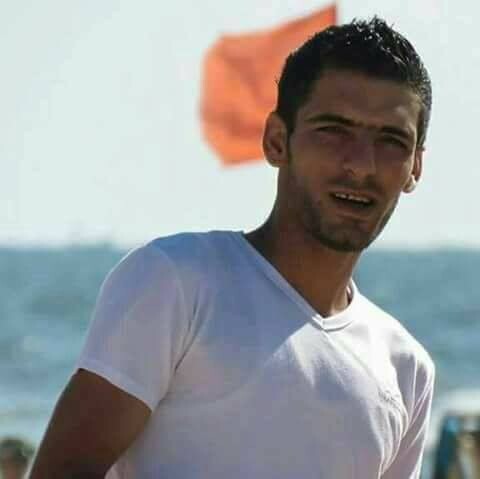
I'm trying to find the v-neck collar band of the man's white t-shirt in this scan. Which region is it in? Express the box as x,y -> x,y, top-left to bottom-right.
231,231 -> 359,331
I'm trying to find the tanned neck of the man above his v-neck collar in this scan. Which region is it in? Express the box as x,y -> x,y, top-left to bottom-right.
245,218 -> 360,317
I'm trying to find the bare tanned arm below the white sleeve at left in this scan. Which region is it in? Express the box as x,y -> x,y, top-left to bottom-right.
29,369 -> 150,479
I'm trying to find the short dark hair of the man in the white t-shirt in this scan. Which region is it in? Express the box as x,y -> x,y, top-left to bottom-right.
276,16 -> 432,147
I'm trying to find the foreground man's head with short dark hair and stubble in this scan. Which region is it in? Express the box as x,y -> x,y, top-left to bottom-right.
264,18 -> 431,252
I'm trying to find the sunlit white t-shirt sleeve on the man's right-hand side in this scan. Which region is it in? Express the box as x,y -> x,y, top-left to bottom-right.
382,361 -> 435,479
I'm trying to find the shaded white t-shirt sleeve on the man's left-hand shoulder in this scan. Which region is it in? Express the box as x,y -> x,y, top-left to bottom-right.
75,244 -> 189,410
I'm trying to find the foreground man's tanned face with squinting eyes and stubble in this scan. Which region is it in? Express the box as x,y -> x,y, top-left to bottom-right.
265,70 -> 422,255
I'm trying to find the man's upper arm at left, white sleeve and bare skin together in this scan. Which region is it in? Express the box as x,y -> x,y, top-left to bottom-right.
31,247 -> 188,479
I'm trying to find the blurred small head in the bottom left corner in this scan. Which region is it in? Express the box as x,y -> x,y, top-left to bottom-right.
0,437 -> 34,479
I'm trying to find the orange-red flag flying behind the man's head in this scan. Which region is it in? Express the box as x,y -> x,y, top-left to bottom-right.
200,5 -> 336,165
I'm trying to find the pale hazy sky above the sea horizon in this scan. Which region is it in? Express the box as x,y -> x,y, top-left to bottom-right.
0,0 -> 480,248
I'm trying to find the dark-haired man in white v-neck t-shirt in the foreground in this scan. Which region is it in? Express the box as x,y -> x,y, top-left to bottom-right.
31,18 -> 434,479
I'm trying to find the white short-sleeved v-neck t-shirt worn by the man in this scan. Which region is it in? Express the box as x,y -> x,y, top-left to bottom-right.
77,231 -> 434,479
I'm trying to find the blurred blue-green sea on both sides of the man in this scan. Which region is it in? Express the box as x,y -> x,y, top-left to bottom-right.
0,243 -> 480,477
